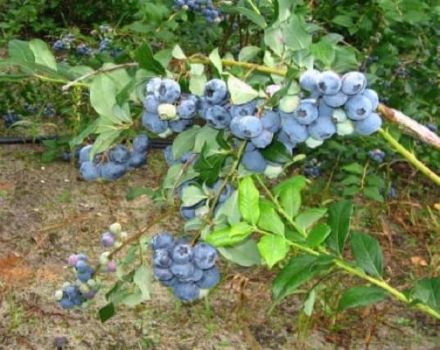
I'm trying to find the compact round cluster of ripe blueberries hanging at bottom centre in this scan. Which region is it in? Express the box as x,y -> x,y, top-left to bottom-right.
151,232 -> 220,302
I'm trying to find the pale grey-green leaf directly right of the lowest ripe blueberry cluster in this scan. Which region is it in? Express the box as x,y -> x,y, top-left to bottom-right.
218,239 -> 261,267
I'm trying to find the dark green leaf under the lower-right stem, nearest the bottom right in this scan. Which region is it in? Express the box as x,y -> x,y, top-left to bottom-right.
338,286 -> 388,311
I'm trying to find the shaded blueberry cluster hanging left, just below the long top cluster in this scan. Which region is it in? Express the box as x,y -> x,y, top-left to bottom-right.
78,134 -> 149,181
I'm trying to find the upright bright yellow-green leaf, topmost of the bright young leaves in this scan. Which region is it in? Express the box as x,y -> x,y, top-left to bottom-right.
238,176 -> 260,225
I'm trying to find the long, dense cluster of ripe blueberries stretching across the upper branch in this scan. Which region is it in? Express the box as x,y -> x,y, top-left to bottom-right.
142,70 -> 382,173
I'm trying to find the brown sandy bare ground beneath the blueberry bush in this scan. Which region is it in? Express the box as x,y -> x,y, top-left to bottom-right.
0,146 -> 440,350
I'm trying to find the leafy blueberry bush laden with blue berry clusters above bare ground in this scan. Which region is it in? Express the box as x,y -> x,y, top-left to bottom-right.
0,0 -> 440,334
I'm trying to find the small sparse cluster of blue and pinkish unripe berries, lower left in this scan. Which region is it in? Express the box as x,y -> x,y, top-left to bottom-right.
55,223 -> 127,309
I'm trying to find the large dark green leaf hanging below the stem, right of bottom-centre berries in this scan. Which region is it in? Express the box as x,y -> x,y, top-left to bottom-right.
272,255 -> 330,300
